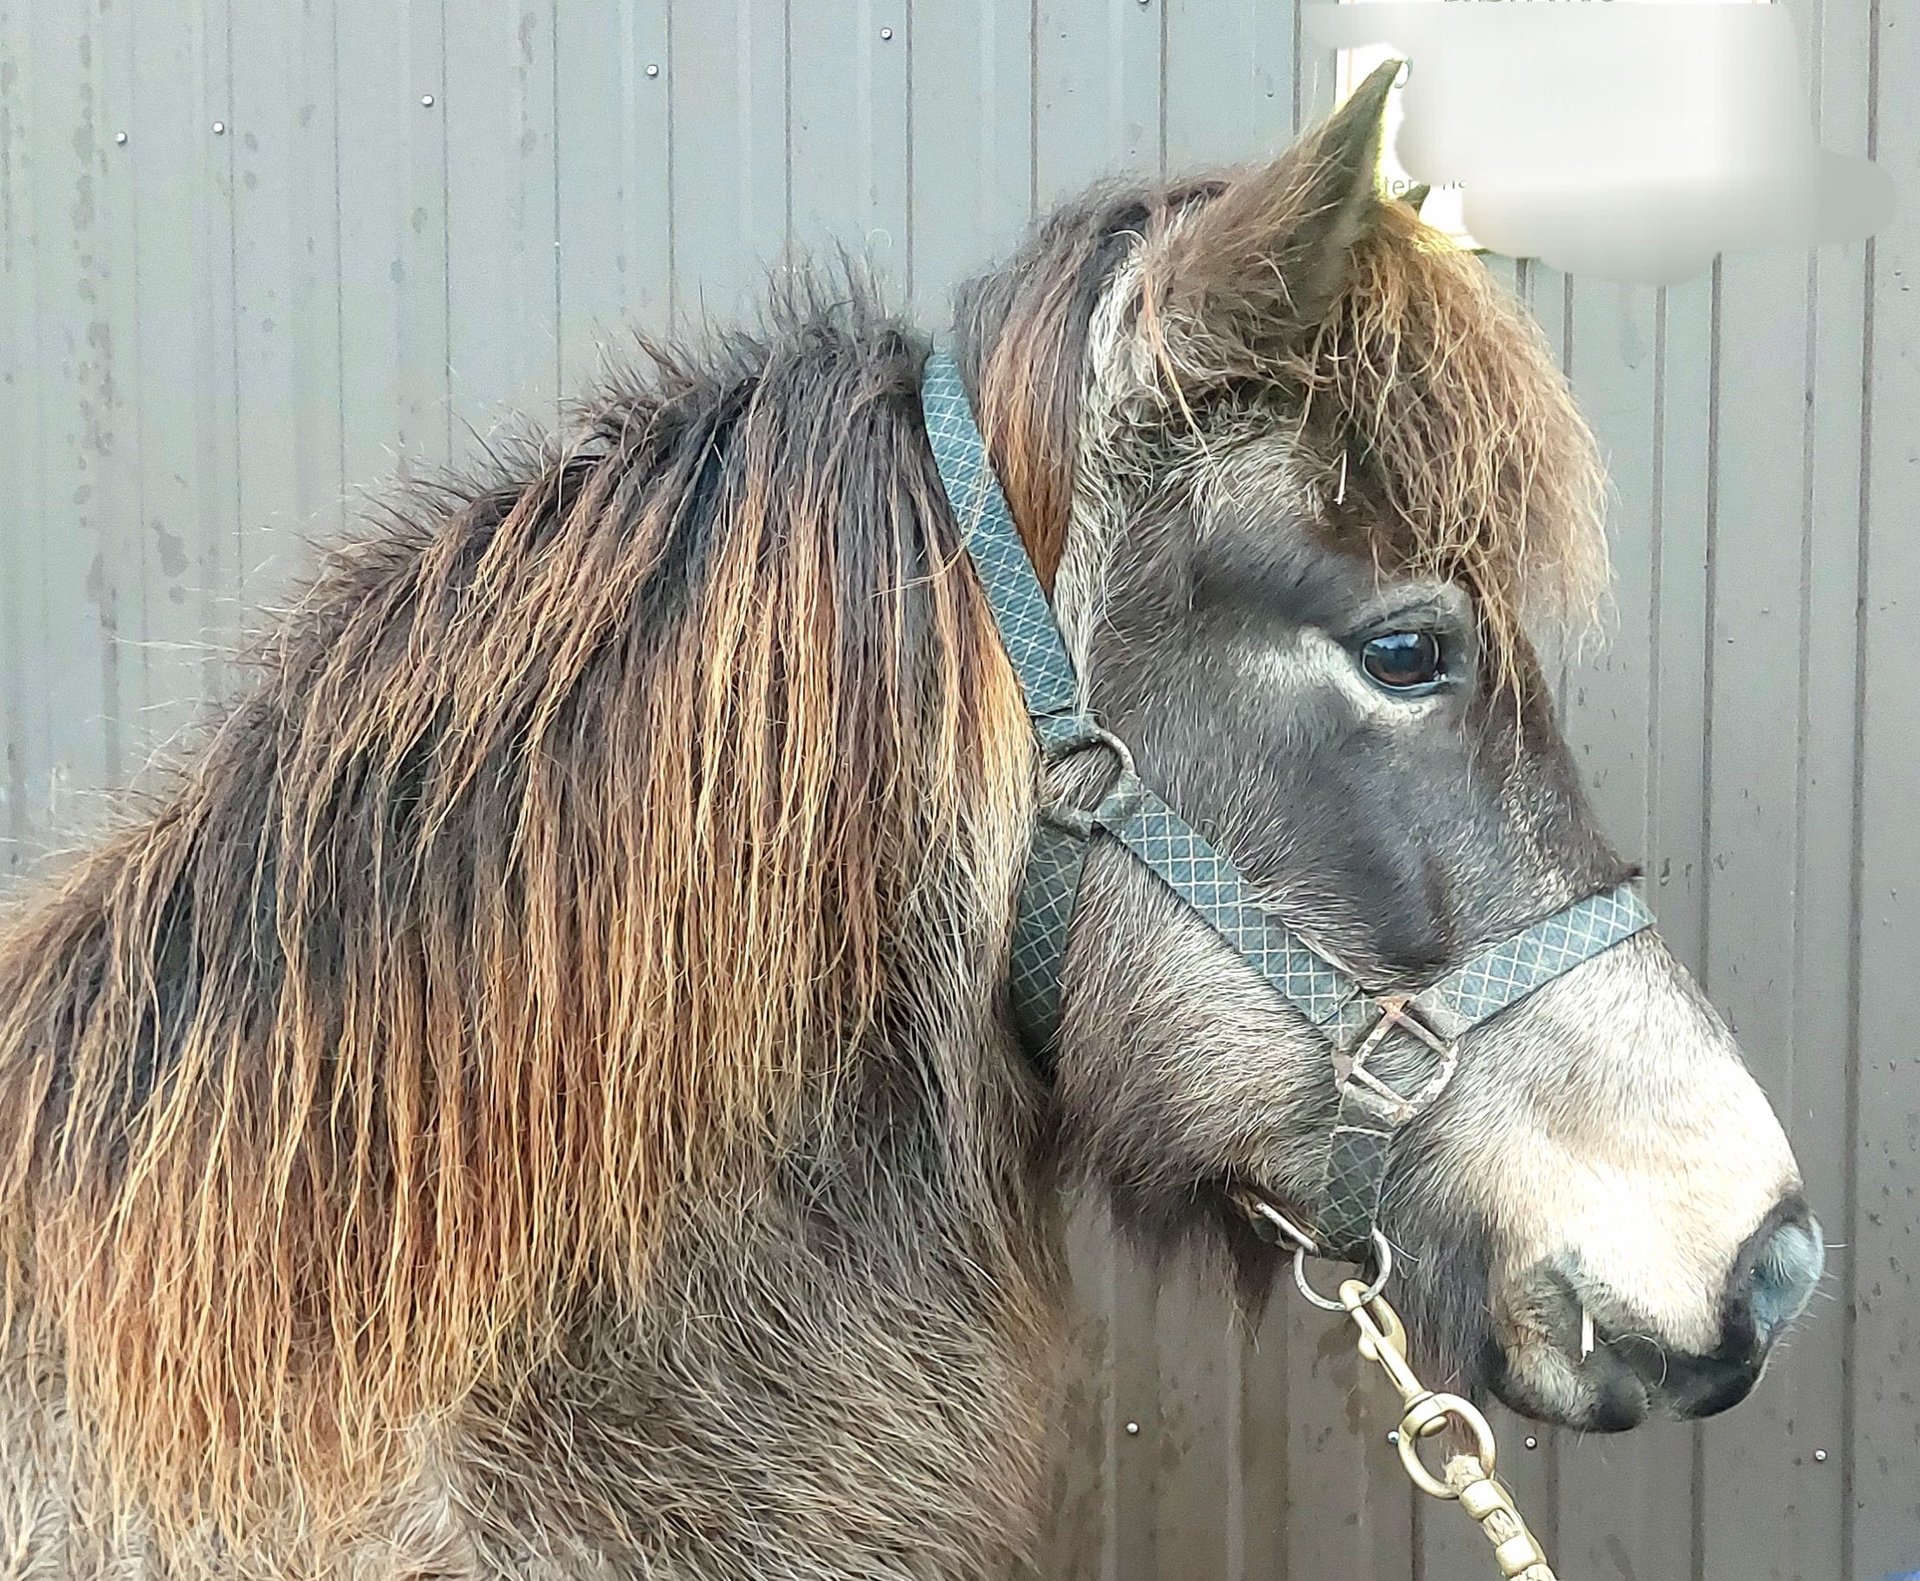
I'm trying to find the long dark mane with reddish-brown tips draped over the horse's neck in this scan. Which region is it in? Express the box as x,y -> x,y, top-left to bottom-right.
0,274 -> 1031,1527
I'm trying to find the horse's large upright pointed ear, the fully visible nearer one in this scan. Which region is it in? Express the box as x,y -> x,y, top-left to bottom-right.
1148,60 -> 1402,382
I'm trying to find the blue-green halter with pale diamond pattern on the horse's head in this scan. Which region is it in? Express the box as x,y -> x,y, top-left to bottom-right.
922,352 -> 1653,1262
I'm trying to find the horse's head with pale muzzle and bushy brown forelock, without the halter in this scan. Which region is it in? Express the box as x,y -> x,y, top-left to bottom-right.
962,67 -> 1822,1429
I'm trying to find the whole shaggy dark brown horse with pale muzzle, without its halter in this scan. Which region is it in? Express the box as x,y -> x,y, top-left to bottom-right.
0,68 -> 1820,1581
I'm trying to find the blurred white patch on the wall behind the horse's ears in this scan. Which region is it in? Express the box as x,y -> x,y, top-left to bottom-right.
1306,0 -> 1893,284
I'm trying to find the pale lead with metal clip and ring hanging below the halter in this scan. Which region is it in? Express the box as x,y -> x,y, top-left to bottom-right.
1340,1279 -> 1555,1581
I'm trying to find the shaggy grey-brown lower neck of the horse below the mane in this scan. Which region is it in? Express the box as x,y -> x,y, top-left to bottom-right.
439,1034 -> 1064,1581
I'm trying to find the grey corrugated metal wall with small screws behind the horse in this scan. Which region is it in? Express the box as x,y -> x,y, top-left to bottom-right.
0,0 -> 1920,1581
